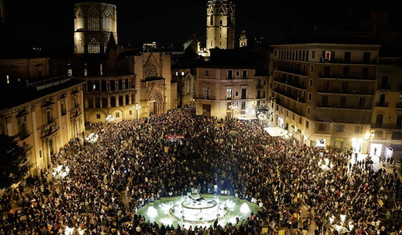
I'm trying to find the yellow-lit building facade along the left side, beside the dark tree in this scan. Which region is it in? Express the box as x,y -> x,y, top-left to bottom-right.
0,77 -> 84,175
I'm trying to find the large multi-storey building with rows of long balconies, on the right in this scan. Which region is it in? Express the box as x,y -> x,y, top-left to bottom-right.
270,43 -> 380,153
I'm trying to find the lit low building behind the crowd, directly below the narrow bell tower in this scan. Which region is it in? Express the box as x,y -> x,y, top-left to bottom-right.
195,66 -> 268,119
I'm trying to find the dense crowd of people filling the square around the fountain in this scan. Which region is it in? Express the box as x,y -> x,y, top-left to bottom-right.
0,105 -> 402,235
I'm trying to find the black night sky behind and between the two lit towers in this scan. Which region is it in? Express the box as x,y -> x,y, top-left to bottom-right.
4,0 -> 396,52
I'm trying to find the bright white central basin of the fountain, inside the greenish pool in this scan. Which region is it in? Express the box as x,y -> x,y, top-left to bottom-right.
164,194 -> 234,223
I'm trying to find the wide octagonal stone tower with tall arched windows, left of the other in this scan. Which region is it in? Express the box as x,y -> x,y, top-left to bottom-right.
74,2 -> 117,54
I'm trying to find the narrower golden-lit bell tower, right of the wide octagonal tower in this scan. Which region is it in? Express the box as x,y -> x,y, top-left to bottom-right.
206,0 -> 236,51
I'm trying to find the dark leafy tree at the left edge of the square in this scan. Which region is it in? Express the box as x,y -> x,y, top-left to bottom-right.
0,134 -> 30,189
